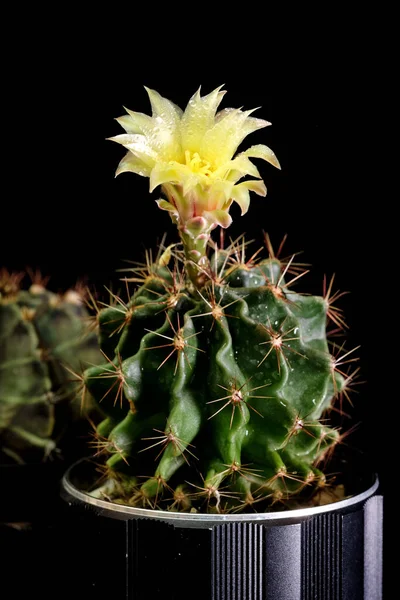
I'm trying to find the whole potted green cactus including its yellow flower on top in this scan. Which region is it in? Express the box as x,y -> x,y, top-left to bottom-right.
84,88 -> 353,512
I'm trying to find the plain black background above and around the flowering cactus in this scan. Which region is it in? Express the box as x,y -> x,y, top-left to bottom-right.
0,5 -> 398,592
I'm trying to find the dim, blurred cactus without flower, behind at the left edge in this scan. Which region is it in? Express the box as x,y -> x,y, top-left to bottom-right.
0,269 -> 103,463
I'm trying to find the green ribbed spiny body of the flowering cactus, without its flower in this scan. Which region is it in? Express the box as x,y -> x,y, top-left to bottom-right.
85,246 -> 345,510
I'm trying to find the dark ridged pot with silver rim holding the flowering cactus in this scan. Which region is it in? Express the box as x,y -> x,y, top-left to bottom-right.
62,461 -> 383,600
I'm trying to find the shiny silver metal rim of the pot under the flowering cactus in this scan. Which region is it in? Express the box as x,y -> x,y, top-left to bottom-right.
61,459 -> 379,527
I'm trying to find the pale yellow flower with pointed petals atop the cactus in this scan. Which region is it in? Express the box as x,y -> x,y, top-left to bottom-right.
110,86 -> 280,227
